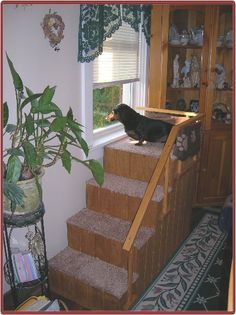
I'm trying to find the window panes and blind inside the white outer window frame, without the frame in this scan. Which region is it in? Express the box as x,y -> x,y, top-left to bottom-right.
93,23 -> 144,130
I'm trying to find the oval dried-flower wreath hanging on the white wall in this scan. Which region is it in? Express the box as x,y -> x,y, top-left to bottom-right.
41,9 -> 65,51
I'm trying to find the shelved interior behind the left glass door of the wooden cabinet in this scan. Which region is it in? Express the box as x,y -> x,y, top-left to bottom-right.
166,6 -> 205,111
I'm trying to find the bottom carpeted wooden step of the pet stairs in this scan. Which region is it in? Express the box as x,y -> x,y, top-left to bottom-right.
49,247 -> 138,310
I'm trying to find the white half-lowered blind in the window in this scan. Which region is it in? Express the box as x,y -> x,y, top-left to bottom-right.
93,22 -> 141,88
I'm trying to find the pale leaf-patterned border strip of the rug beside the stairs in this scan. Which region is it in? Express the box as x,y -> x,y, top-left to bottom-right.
131,213 -> 227,311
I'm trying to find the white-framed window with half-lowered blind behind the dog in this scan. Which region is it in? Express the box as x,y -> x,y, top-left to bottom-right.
81,22 -> 148,145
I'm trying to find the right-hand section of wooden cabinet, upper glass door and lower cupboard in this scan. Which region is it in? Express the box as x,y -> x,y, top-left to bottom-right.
197,5 -> 234,205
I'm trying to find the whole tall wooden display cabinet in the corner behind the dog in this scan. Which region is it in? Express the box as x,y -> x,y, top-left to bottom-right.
148,4 -> 234,205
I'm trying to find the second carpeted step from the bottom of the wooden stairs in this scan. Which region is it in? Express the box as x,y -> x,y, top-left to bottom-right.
67,209 -> 155,270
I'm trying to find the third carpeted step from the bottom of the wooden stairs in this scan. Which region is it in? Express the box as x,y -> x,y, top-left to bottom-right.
86,173 -> 171,227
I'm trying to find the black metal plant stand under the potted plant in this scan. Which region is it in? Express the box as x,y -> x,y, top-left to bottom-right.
4,204 -> 49,308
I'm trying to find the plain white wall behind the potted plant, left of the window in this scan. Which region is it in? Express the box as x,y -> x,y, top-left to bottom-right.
3,4 -> 102,290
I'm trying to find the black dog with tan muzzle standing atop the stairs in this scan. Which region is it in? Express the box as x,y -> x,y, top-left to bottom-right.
106,104 -> 173,145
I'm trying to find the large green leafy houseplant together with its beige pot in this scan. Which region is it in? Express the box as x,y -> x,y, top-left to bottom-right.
3,54 -> 104,215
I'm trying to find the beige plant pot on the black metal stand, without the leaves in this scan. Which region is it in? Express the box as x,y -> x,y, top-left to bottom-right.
3,171 -> 44,215
